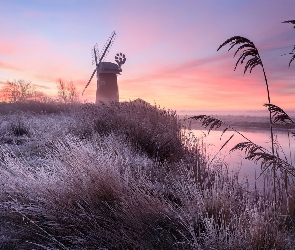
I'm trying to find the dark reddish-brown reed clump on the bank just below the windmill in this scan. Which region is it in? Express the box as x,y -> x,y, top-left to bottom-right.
71,100 -> 183,162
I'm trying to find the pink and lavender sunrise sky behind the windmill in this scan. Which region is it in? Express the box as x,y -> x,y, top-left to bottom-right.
0,0 -> 295,110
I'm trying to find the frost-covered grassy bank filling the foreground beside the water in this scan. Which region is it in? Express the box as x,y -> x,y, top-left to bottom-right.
0,102 -> 295,249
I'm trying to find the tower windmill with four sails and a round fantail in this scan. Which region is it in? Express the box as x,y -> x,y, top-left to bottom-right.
82,31 -> 126,104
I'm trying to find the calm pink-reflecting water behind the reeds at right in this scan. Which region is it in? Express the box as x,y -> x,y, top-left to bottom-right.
192,129 -> 295,188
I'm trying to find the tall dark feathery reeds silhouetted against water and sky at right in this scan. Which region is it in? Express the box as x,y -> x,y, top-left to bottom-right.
191,26 -> 295,215
